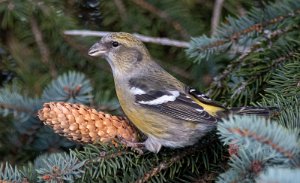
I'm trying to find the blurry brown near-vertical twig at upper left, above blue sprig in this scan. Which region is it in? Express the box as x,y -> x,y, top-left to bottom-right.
30,17 -> 57,78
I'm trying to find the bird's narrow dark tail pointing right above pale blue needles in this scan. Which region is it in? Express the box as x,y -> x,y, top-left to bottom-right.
221,106 -> 279,118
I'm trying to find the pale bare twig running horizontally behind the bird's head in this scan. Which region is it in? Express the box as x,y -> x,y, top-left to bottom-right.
64,30 -> 189,48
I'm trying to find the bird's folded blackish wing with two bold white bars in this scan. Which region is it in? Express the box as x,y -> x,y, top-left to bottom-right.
130,78 -> 223,123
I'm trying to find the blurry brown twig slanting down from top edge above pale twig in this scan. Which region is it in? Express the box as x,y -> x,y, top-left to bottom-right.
132,0 -> 190,39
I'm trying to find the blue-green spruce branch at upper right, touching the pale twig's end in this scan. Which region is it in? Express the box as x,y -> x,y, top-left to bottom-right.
187,1 -> 300,62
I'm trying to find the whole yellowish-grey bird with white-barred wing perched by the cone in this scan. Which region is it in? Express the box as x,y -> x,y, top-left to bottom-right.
88,32 -> 276,153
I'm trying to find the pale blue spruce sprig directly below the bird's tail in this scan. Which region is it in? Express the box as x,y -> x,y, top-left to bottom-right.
218,116 -> 300,161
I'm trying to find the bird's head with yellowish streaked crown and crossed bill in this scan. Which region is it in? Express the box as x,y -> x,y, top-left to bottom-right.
88,32 -> 150,73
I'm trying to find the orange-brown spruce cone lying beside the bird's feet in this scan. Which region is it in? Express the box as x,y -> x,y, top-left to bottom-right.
38,102 -> 137,143
